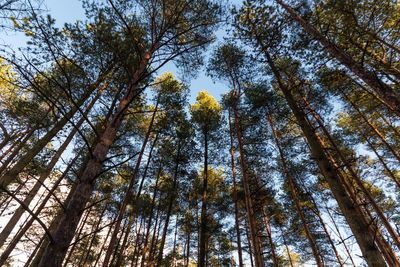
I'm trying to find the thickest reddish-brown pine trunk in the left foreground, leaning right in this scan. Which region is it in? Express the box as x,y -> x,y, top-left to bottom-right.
39,52 -> 152,267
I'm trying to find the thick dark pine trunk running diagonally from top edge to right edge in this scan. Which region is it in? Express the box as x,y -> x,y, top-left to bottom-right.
275,0 -> 400,116
